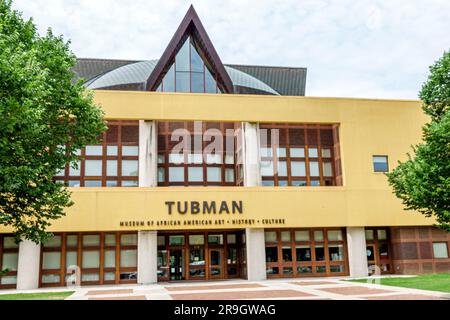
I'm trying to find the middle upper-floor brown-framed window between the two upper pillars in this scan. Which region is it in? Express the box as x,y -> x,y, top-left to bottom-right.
158,122 -> 243,186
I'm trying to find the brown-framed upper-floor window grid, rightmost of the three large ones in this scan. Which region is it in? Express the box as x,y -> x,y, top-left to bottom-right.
260,124 -> 342,186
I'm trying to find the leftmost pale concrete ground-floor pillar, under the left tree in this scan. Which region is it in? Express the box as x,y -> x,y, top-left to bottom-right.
17,240 -> 41,290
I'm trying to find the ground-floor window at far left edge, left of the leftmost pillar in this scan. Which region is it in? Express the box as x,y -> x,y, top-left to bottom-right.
0,235 -> 19,289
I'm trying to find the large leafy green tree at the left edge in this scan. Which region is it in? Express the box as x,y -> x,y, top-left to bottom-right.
0,0 -> 106,243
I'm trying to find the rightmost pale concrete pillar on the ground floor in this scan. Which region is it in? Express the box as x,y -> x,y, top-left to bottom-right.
347,228 -> 369,277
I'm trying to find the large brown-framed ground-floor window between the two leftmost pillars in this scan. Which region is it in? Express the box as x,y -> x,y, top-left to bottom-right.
40,232 -> 137,287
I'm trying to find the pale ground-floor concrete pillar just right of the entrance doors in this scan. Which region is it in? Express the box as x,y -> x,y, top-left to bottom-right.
245,228 -> 267,281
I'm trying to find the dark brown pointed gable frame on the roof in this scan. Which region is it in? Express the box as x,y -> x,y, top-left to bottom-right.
147,5 -> 233,93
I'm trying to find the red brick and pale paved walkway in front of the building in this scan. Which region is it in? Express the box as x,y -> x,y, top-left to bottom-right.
0,278 -> 450,300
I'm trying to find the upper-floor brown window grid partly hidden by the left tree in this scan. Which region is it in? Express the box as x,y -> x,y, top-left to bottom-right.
54,120 -> 139,187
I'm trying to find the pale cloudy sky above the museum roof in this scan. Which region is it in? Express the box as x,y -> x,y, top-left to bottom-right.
13,0 -> 450,99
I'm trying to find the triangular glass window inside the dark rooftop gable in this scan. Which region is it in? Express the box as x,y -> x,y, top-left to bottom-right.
156,37 -> 222,93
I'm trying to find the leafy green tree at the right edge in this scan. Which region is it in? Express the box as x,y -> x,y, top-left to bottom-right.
388,52 -> 450,231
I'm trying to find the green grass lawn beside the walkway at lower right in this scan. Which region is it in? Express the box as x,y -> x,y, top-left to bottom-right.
349,273 -> 450,292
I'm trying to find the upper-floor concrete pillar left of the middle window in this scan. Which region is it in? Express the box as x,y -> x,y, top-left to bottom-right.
139,120 -> 158,187
